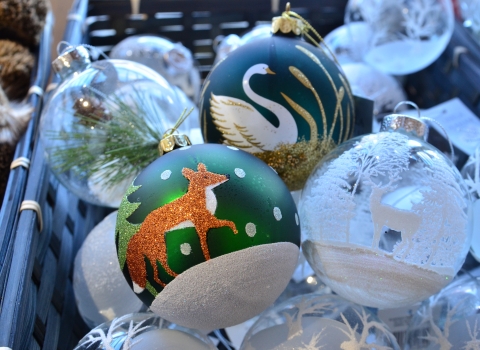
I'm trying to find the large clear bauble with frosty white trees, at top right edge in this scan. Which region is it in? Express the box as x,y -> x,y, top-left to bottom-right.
345,0 -> 454,75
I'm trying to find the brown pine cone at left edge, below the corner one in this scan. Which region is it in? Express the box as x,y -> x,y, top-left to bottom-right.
0,40 -> 35,100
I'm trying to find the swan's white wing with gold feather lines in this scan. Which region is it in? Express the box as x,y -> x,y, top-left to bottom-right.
210,93 -> 274,153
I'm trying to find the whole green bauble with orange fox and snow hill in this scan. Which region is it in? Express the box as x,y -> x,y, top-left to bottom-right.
117,144 -> 300,330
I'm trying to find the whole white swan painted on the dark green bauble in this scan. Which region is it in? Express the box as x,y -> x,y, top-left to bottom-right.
210,63 -> 298,153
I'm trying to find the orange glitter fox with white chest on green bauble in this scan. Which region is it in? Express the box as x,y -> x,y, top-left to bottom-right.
127,163 -> 238,293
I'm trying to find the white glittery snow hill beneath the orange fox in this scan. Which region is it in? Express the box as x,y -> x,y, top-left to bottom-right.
150,242 -> 299,330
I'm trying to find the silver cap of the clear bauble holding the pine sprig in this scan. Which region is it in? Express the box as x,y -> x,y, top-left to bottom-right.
52,46 -> 91,80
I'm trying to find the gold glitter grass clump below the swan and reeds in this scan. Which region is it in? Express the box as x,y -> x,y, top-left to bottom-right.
254,139 -> 336,191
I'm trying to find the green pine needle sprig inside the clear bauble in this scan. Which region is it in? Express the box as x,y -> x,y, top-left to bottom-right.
46,87 -> 172,187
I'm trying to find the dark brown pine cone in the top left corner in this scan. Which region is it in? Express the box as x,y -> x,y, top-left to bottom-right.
0,0 -> 50,46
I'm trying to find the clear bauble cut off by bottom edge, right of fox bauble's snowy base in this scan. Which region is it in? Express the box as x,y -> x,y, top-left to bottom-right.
240,294 -> 400,350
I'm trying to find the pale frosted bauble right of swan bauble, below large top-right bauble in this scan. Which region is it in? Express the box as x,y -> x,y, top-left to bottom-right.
342,63 -> 407,115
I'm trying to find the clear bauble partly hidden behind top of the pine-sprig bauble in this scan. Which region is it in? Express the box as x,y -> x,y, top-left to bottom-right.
110,35 -> 200,102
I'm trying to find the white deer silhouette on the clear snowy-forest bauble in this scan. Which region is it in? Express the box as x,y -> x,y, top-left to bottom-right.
370,181 -> 422,258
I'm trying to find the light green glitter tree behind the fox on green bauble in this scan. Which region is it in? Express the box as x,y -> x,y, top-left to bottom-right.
115,184 -> 142,270
